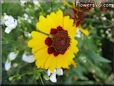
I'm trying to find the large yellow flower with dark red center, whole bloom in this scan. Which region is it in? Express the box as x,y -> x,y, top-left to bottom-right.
28,10 -> 78,72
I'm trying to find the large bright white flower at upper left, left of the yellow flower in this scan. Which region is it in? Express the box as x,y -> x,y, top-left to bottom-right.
2,14 -> 17,33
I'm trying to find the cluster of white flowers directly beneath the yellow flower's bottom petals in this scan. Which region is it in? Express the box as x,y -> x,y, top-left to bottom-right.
45,68 -> 63,83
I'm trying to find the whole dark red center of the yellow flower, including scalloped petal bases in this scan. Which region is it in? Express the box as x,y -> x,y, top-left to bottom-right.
45,26 -> 70,56
